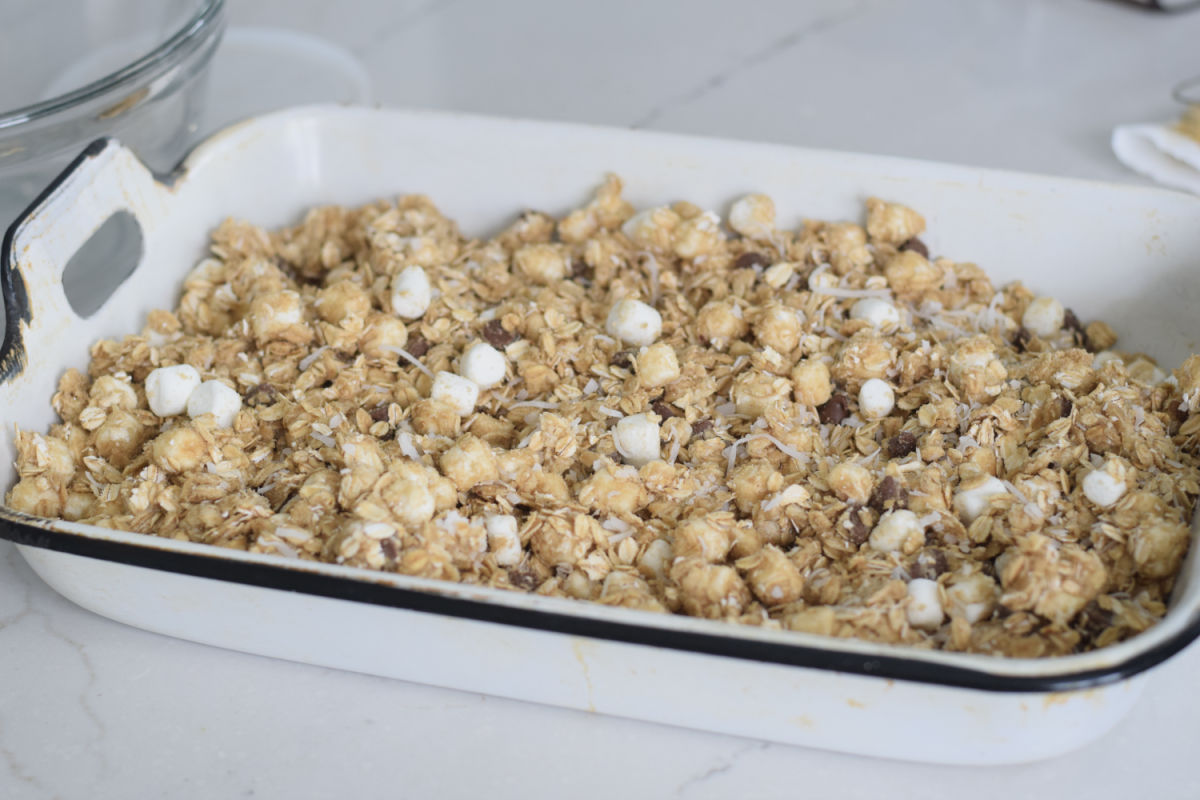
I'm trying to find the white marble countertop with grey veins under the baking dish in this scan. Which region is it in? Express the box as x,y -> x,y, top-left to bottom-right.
7,0 -> 1200,800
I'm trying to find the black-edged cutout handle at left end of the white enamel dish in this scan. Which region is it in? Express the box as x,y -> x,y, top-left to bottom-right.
0,138 -> 169,384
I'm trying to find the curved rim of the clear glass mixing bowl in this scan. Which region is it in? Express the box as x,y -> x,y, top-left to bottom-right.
0,0 -> 224,130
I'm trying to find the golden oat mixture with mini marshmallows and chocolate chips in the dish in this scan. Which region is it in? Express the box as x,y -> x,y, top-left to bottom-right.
8,178 -> 1200,656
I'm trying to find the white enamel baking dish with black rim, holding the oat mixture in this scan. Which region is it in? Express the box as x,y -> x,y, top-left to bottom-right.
0,108 -> 1200,764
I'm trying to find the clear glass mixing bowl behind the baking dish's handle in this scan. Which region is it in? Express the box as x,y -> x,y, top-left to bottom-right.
0,0 -> 224,229
